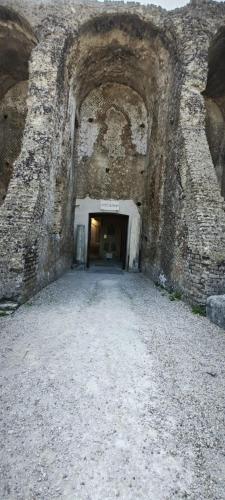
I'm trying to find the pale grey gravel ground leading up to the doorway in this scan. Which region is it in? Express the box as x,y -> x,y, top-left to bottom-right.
0,271 -> 225,500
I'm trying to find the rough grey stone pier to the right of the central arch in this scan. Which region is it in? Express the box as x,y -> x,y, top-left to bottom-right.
170,3 -> 225,303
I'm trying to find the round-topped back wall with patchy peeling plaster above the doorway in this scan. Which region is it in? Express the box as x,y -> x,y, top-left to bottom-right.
76,83 -> 148,206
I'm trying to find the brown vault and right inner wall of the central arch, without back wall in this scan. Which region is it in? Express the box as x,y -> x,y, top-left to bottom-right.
68,13 -> 179,276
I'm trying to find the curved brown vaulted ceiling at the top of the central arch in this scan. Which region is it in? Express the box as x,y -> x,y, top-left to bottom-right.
69,13 -> 175,112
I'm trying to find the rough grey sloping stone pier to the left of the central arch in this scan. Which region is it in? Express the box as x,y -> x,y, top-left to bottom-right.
0,11 -> 73,300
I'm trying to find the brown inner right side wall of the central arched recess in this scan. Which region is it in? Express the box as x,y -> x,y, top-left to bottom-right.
142,34 -> 182,281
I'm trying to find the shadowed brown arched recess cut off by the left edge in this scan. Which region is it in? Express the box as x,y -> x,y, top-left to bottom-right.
0,6 -> 36,206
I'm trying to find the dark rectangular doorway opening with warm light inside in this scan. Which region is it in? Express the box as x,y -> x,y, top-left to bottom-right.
87,213 -> 129,269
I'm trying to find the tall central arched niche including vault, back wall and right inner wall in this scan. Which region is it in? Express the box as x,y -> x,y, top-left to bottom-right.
67,13 -> 180,278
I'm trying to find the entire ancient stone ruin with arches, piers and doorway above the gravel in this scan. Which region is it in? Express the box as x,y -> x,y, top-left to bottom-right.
0,0 -> 225,304
